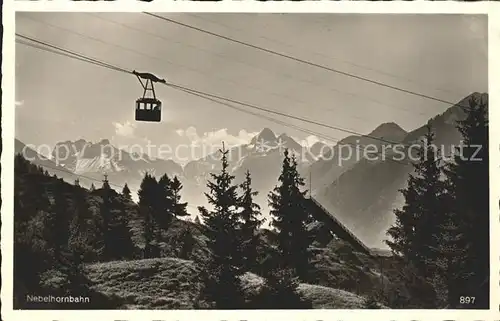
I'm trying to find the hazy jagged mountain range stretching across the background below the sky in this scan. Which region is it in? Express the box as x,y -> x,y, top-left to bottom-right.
15,93 -> 488,248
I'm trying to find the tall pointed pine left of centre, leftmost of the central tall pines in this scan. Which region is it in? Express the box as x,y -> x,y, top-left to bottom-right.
199,144 -> 244,309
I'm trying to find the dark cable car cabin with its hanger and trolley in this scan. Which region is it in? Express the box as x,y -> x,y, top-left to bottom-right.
132,70 -> 166,122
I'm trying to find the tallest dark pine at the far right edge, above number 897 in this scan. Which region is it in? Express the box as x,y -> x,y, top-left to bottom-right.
445,97 -> 490,308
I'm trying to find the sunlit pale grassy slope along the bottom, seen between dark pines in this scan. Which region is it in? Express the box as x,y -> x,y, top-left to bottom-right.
87,258 -> 370,309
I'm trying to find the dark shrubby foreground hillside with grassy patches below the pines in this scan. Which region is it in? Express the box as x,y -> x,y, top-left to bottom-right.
14,157 -> 391,309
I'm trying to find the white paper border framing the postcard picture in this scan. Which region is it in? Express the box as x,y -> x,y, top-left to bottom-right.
1,0 -> 500,321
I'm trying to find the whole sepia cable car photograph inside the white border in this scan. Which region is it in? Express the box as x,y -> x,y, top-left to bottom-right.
9,12 -> 490,310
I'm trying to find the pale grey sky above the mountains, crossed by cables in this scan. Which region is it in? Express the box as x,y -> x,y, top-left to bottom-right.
15,12 -> 488,162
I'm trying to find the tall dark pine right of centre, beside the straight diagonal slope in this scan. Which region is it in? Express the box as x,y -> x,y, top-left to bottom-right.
269,150 -> 312,281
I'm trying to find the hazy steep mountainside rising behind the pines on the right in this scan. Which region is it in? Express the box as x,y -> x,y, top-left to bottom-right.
316,93 -> 488,248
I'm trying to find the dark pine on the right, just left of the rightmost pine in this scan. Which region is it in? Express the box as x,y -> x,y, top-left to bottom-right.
386,126 -> 445,308
